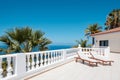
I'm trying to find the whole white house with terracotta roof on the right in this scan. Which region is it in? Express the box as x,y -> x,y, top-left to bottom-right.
91,27 -> 120,52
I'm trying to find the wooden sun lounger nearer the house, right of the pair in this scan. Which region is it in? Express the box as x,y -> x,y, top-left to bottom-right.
90,52 -> 114,65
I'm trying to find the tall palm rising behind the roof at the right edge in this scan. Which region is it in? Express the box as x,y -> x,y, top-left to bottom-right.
105,9 -> 120,30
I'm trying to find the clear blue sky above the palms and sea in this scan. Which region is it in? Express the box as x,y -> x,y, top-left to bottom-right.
0,0 -> 120,44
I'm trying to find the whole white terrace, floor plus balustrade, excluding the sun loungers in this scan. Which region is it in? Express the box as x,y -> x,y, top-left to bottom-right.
0,48 -> 120,80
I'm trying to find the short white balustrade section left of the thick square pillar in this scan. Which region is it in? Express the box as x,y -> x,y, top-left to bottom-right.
0,54 -> 16,80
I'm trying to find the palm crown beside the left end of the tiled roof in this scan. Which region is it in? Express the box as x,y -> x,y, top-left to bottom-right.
85,24 -> 102,38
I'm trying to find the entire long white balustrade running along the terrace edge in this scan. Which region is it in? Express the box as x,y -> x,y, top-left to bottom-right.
0,47 -> 110,80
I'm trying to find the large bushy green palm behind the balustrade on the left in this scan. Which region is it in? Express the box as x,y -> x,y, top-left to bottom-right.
0,27 -> 51,53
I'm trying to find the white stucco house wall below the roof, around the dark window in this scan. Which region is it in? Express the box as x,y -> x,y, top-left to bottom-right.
93,32 -> 120,52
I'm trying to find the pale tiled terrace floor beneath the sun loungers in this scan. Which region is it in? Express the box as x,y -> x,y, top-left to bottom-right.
27,53 -> 120,80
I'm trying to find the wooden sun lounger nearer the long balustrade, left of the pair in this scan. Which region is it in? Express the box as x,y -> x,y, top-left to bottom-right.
75,52 -> 99,66
